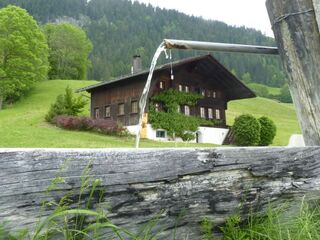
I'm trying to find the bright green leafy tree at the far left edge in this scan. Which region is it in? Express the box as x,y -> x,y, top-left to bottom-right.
0,6 -> 48,108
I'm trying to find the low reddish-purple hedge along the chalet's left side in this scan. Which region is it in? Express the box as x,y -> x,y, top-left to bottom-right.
52,116 -> 129,136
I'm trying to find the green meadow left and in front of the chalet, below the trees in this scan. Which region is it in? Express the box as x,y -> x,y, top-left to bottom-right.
0,80 -> 212,148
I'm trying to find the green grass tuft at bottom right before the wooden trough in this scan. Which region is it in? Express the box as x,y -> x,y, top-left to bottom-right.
219,201 -> 320,240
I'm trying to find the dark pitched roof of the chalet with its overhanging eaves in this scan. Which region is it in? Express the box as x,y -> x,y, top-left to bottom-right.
77,55 -> 256,101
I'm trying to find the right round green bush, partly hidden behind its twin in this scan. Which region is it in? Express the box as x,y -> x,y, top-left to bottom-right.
258,117 -> 277,146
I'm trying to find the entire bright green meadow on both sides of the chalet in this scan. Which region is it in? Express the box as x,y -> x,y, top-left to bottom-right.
0,80 -> 299,148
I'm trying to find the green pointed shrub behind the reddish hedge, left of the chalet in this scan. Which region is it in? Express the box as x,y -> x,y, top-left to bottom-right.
45,87 -> 87,122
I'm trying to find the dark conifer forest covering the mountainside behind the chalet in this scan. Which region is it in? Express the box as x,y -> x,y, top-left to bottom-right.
0,0 -> 285,87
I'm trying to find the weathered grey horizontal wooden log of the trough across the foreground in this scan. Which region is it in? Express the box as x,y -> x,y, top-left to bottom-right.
0,147 -> 320,239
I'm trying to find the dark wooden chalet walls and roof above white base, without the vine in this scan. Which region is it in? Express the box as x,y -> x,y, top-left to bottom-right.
81,55 -> 255,126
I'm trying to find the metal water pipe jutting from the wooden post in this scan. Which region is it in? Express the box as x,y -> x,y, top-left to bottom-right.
164,39 -> 279,55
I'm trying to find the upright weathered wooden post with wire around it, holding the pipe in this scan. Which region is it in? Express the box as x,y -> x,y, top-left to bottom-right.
266,0 -> 320,146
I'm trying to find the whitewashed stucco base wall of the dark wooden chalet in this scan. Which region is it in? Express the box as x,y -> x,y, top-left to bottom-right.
126,124 -> 229,145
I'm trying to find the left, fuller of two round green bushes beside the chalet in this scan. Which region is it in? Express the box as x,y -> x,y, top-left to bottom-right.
232,114 -> 261,146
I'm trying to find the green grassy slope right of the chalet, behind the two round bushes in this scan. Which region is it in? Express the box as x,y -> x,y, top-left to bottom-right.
227,98 -> 300,146
